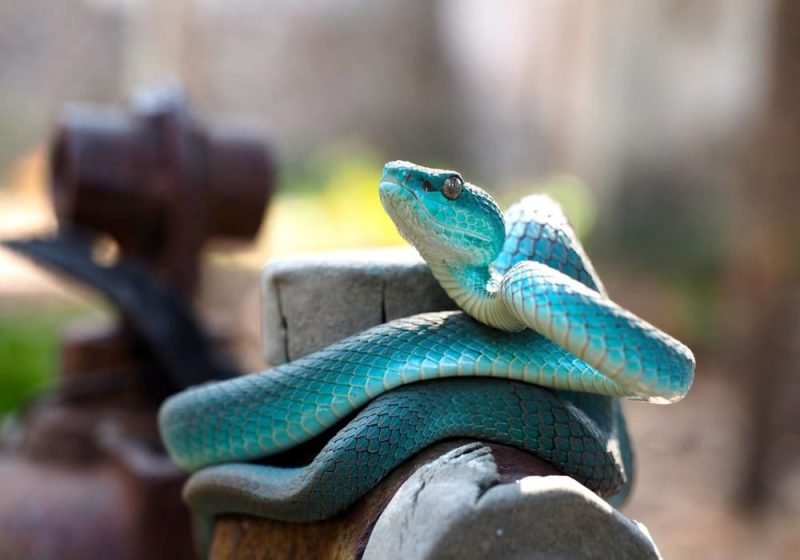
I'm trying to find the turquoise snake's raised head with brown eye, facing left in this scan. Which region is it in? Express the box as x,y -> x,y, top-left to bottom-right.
379,161 -> 505,265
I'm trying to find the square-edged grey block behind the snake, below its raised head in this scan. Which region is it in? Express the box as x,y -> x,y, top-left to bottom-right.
261,249 -> 456,366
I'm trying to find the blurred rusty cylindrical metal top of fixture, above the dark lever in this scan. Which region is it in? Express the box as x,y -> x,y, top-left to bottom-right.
50,85 -> 274,296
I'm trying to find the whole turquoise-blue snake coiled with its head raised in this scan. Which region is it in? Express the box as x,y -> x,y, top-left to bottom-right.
159,161 -> 694,548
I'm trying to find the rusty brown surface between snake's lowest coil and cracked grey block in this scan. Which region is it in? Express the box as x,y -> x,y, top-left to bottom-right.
210,439 -> 560,560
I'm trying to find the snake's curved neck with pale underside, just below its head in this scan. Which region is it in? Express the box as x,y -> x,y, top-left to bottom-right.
426,259 -> 525,332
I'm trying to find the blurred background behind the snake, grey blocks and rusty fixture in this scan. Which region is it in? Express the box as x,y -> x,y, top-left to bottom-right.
0,0 -> 800,559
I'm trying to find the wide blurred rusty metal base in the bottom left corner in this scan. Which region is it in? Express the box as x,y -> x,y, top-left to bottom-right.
0,407 -> 194,560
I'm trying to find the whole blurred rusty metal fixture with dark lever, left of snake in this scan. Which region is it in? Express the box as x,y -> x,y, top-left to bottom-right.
0,84 -> 274,560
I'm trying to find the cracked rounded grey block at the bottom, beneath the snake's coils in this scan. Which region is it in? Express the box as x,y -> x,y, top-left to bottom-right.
363,444 -> 661,560
